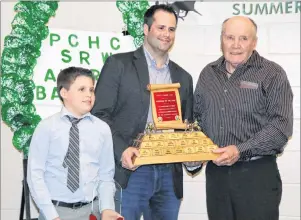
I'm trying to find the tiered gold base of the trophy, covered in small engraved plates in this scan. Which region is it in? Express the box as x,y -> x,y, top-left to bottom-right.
134,131 -> 219,166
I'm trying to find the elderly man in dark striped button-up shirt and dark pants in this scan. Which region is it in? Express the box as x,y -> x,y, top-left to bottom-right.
194,16 -> 293,220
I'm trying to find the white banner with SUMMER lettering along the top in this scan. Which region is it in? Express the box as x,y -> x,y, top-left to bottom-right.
153,1 -> 301,25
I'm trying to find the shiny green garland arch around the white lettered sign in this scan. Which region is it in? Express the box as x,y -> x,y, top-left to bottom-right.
1,0 -> 149,157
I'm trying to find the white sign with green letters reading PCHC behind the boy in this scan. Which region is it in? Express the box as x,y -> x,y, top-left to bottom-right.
33,29 -> 135,118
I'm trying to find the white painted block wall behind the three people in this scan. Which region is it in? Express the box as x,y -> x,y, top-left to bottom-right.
1,2 -> 300,220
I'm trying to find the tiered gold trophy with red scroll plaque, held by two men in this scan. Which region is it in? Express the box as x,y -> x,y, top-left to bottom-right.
133,83 -> 218,166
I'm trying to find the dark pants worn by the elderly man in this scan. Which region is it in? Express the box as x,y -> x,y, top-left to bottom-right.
206,156 -> 282,220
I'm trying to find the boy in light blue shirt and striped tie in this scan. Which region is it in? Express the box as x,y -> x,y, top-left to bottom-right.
27,67 -> 120,220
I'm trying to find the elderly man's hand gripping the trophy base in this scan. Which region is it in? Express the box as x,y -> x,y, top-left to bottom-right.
212,145 -> 240,166
